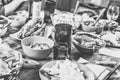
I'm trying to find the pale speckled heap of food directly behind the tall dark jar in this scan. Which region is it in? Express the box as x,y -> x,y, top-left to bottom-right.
51,12 -> 82,29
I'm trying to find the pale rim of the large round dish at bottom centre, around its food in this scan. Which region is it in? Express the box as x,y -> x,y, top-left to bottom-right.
39,60 -> 95,80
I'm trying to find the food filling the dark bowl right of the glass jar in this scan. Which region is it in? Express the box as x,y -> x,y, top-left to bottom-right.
73,33 -> 104,49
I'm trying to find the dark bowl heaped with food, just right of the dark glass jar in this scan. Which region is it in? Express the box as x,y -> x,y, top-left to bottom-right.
72,32 -> 106,55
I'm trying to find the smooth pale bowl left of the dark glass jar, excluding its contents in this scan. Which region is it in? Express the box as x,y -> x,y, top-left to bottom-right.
21,36 -> 54,60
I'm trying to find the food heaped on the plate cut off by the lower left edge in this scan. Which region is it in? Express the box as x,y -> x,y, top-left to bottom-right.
0,50 -> 22,70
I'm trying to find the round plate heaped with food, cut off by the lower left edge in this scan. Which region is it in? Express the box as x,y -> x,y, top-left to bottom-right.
0,49 -> 23,77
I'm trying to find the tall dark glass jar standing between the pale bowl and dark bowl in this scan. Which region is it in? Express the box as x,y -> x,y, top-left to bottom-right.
54,23 -> 72,59
